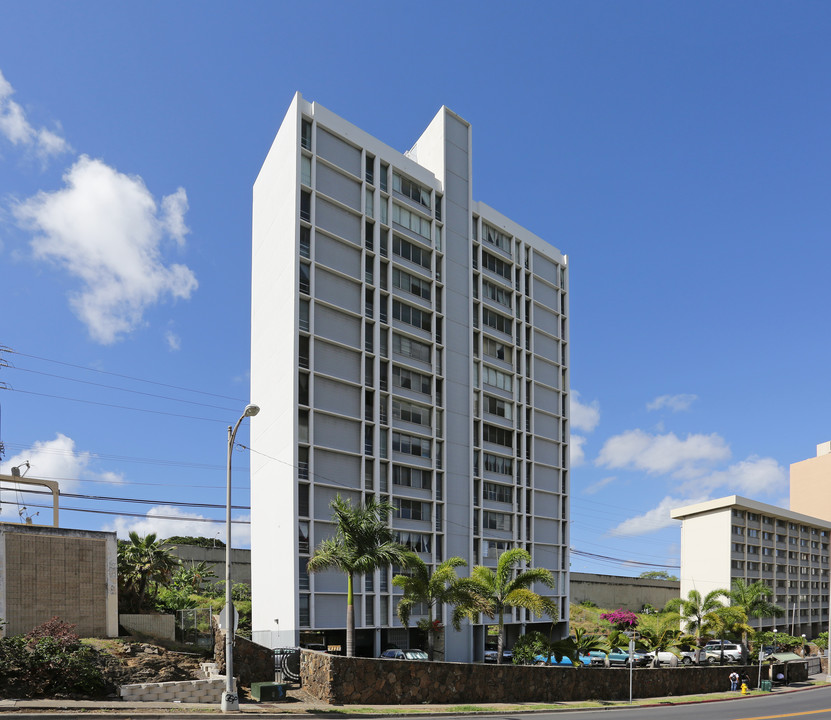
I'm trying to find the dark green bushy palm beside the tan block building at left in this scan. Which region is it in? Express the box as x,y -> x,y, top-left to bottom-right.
117,531 -> 178,612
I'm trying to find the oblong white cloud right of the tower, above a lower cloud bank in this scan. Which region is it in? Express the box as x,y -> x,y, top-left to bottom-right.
595,430 -> 730,477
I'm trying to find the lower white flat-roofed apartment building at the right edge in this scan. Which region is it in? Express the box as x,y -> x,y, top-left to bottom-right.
671,495 -> 831,639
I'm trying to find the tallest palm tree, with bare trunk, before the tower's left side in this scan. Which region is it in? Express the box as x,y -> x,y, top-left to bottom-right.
308,495 -> 418,657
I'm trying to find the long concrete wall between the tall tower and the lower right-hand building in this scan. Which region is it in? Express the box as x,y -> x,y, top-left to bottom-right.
571,573 -> 681,612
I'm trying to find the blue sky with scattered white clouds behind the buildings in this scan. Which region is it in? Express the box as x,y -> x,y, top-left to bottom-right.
0,0 -> 831,575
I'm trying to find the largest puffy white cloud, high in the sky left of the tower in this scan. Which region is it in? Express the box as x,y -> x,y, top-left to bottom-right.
14,155 -> 198,344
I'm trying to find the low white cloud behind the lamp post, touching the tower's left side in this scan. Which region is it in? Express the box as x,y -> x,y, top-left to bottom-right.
108,505 -> 251,548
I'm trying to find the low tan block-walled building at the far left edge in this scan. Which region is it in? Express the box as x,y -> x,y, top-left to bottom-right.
0,523 -> 118,637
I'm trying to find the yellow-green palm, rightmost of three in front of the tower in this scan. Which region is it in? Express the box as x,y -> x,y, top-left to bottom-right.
458,548 -> 557,663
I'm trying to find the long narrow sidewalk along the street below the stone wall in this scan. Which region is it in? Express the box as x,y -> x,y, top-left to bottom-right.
0,675 -> 827,720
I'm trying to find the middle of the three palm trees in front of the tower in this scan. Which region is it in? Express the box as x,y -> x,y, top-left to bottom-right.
392,555 -> 478,660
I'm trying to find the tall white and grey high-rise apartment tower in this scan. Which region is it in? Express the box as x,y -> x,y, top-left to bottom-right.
251,94 -> 569,661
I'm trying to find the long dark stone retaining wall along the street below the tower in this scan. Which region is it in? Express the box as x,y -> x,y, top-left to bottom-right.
300,649 -> 807,705
